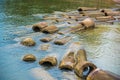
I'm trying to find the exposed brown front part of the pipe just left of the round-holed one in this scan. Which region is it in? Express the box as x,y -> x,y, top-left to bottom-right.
59,52 -> 75,70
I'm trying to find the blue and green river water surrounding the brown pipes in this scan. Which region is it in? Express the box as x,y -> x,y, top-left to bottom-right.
0,0 -> 120,80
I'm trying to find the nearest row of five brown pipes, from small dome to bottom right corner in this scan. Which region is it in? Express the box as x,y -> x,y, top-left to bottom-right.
23,42 -> 120,80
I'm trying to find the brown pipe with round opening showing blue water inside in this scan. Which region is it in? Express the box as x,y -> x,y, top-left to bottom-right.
74,49 -> 97,78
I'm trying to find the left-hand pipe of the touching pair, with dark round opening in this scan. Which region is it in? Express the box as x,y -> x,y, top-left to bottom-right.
32,22 -> 48,32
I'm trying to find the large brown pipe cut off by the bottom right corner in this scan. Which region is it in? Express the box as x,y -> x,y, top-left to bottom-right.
86,68 -> 120,80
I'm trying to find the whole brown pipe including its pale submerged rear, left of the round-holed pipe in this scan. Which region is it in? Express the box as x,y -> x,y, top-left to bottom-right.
59,42 -> 80,70
